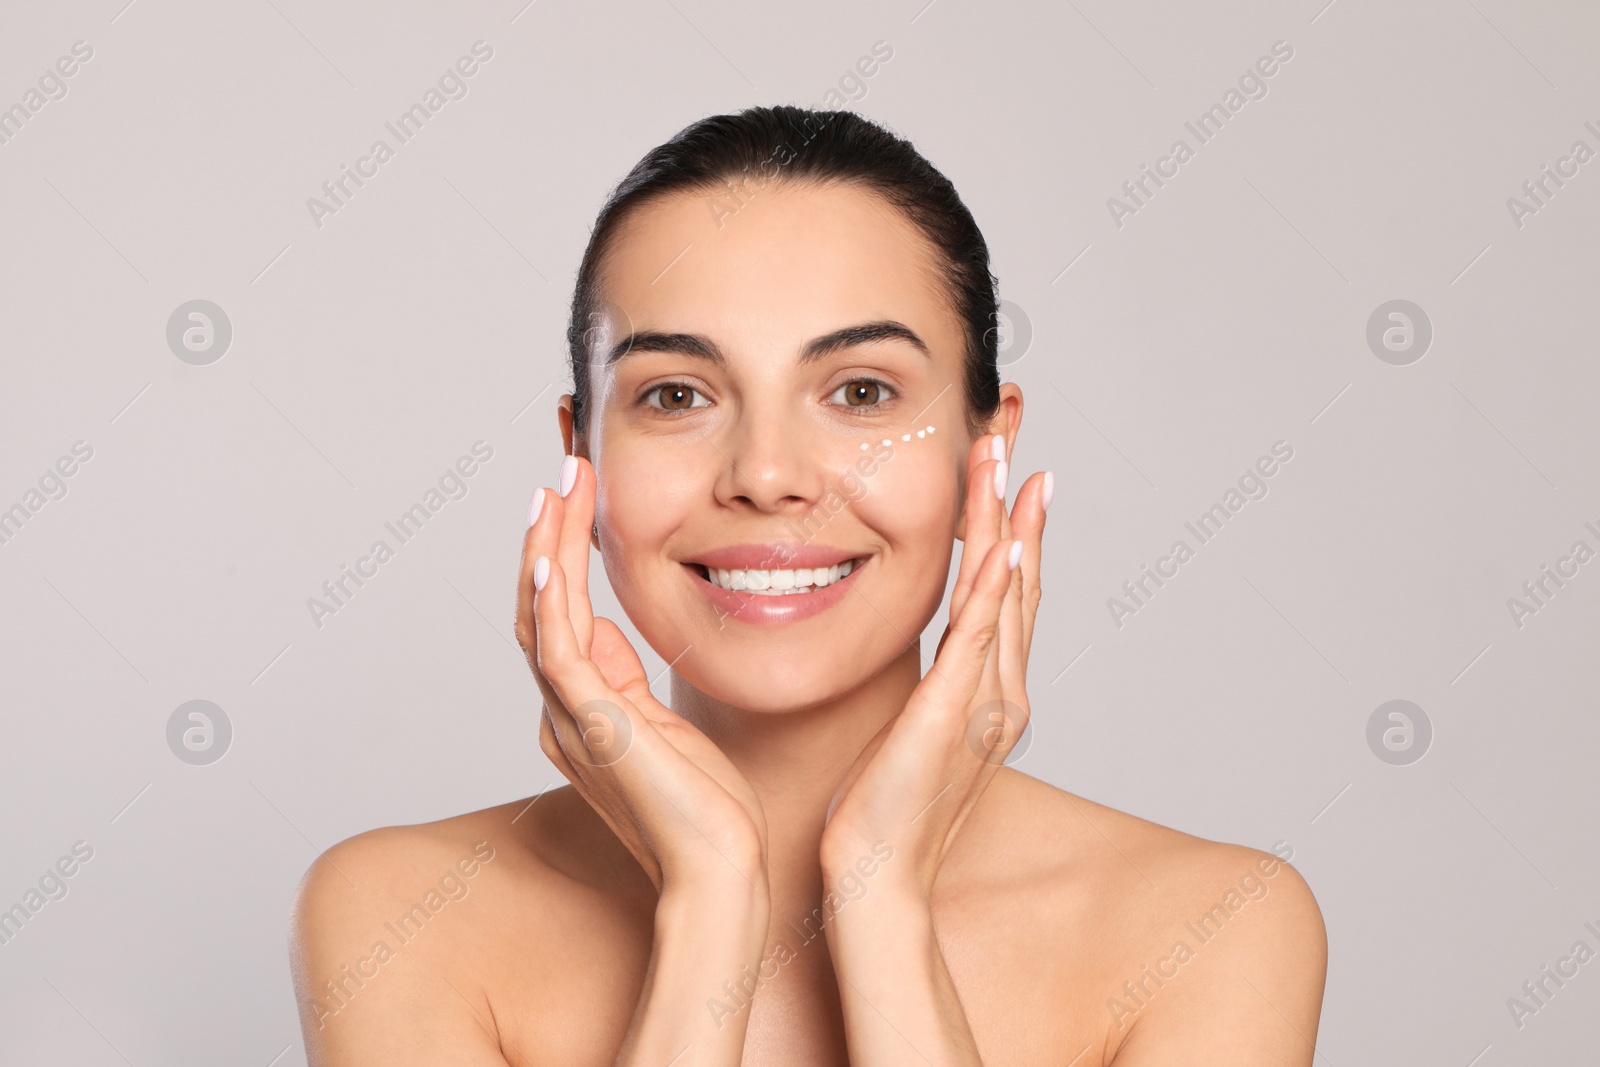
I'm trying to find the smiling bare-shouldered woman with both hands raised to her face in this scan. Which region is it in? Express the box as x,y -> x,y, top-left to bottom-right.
293,107 -> 1326,1067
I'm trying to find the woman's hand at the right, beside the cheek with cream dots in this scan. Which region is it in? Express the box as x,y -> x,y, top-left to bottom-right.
821,435 -> 1053,901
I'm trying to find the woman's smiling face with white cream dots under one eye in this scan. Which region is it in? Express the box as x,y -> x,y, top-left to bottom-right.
581,184 -> 998,712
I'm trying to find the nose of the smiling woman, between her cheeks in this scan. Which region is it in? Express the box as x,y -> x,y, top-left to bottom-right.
720,405 -> 827,515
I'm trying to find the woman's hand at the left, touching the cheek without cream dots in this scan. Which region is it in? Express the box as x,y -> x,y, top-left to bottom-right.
517,456 -> 766,904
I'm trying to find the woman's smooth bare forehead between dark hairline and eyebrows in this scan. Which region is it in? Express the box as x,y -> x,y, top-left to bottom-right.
600,182 -> 962,354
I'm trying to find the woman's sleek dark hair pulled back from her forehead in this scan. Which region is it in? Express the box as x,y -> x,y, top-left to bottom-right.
566,106 -> 1000,434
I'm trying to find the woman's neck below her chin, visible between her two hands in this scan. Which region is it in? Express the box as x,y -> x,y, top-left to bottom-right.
672,638 -> 922,917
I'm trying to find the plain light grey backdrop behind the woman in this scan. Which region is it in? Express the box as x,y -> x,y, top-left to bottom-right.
0,0 -> 1600,1067
